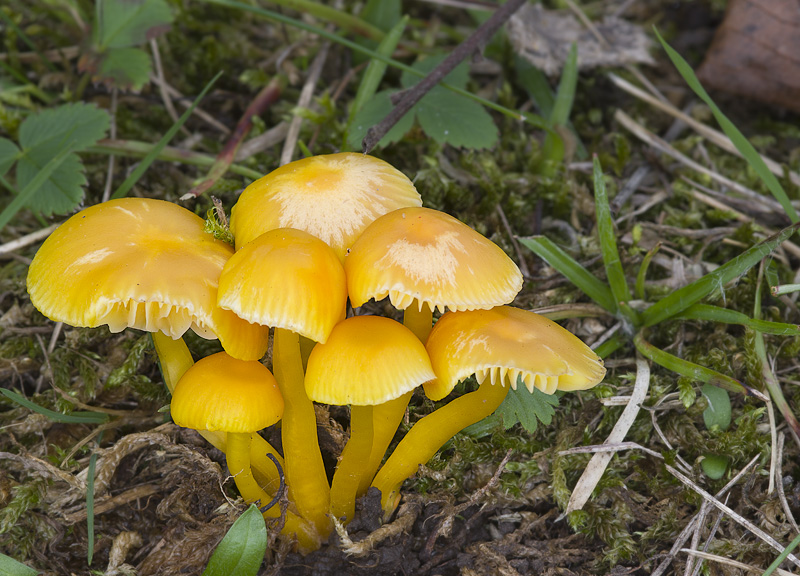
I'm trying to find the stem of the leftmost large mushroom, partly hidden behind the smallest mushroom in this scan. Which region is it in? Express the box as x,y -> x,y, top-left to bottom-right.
152,332 -> 284,490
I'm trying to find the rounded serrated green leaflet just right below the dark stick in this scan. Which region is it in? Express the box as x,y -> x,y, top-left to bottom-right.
414,86 -> 498,149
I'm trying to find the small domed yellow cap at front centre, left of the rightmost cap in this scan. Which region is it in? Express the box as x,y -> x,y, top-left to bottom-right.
306,316 -> 435,406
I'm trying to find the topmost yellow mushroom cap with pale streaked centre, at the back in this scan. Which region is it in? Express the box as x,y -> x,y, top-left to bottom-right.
231,152 -> 422,260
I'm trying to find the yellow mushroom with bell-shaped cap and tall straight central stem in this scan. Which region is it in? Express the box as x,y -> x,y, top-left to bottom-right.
219,228 -> 347,534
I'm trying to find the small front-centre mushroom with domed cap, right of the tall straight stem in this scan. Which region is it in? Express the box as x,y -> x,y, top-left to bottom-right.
305,316 -> 435,522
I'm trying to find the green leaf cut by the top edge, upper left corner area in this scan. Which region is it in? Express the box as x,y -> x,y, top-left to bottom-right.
95,0 -> 172,52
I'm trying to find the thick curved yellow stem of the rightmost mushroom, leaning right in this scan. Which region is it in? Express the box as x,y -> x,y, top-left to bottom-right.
372,379 -> 508,519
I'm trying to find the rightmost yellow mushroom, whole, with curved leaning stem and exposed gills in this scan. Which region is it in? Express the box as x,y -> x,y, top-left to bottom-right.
372,306 -> 606,517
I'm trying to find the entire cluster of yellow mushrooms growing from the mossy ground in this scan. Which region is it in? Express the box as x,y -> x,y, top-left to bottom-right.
23,153 -> 605,551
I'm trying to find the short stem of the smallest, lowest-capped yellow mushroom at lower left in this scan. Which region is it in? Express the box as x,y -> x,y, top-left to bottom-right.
225,432 -> 320,553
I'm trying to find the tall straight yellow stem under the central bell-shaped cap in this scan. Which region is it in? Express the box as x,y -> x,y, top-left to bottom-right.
272,328 -> 331,538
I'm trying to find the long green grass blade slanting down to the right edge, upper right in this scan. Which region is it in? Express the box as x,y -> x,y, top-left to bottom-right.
654,29 -> 800,223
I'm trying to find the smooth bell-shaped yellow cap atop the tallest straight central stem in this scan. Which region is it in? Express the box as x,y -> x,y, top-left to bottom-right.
219,228 -> 347,342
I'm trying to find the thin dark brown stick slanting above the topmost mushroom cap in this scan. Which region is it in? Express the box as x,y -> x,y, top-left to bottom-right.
361,0 -> 527,154
